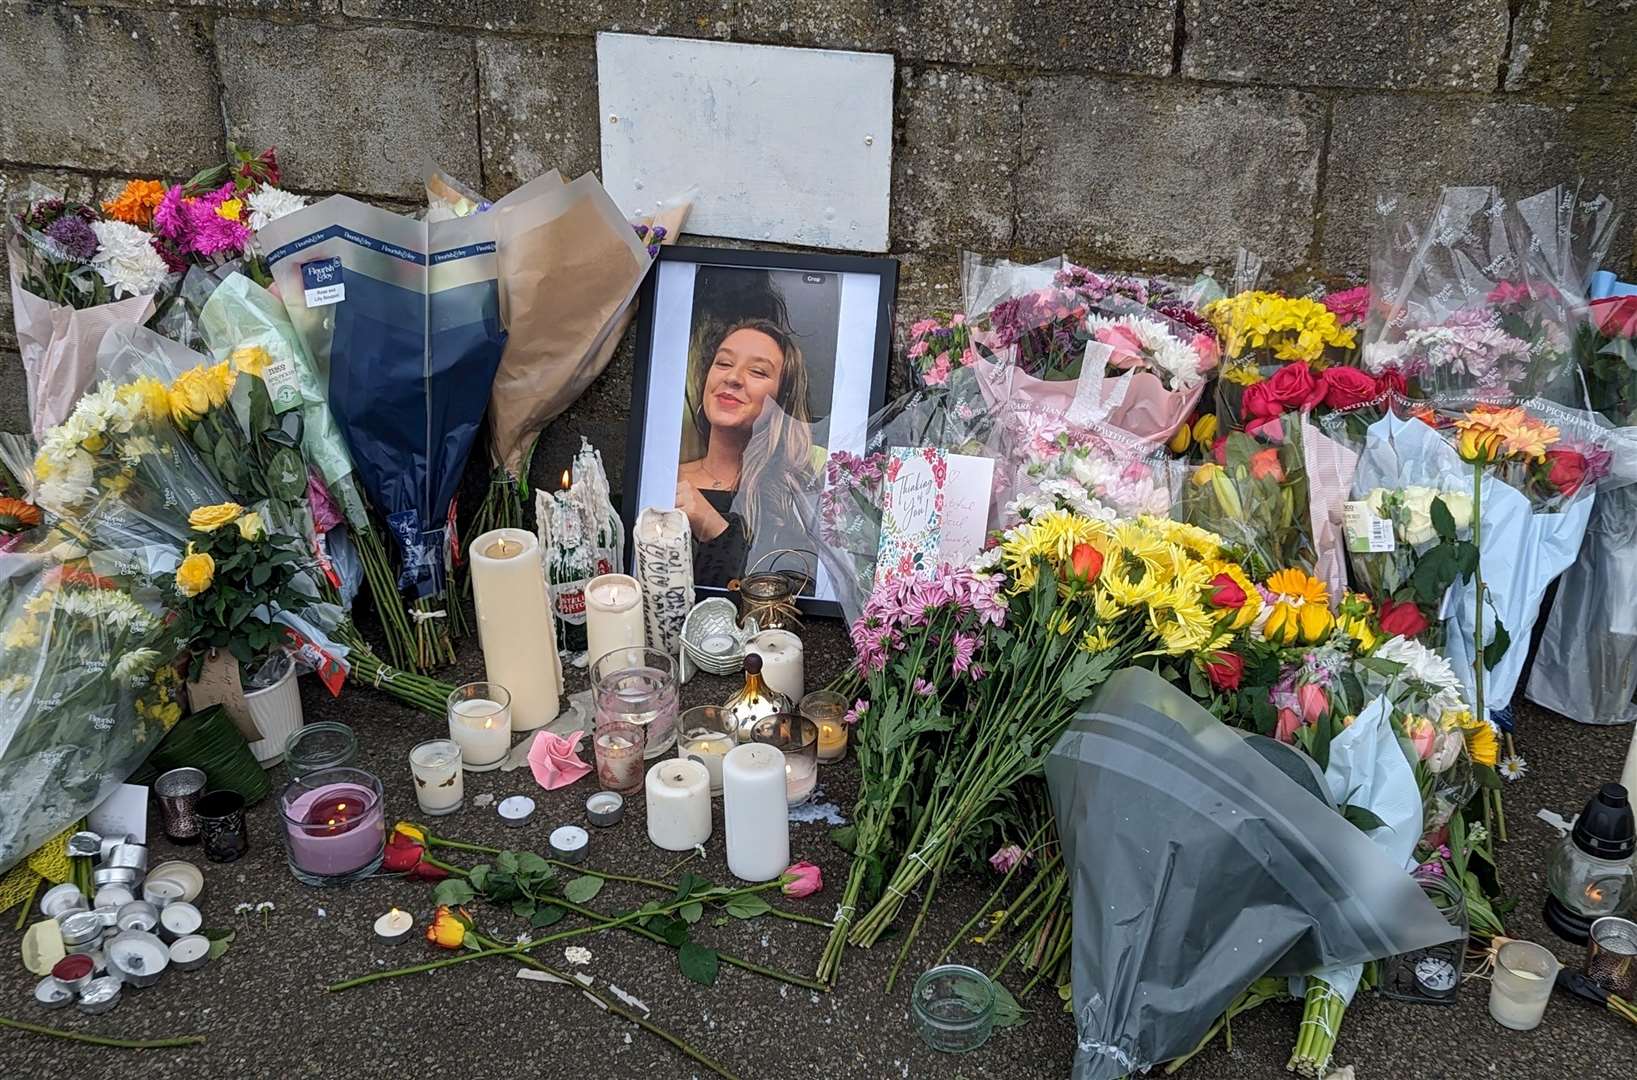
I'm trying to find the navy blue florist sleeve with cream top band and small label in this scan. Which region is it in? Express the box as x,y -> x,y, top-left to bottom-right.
257,195 -> 506,612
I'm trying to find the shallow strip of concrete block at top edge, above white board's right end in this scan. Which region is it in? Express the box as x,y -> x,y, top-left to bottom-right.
733,0 -> 1175,75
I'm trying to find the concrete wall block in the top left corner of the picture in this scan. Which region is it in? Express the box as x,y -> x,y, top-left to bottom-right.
0,3 -> 223,173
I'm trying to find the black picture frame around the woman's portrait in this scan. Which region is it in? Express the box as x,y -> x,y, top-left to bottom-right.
620,245 -> 899,619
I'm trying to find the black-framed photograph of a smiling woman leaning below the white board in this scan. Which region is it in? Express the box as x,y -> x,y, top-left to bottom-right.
624,247 -> 899,614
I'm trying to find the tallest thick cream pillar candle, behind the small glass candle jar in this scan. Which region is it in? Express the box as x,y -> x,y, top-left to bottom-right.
470,529 -> 560,731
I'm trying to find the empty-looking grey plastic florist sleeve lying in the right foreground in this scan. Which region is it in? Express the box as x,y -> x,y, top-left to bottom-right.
1046,669 -> 1459,1080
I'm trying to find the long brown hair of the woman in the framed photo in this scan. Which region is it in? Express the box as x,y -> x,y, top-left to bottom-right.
688,319 -> 814,538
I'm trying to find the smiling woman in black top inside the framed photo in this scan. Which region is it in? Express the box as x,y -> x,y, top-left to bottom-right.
676,319 -> 812,584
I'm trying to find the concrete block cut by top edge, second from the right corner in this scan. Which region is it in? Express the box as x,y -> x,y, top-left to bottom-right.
1182,0 -> 1508,90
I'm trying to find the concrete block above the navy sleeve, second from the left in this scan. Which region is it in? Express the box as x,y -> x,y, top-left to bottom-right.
216,18 -> 481,200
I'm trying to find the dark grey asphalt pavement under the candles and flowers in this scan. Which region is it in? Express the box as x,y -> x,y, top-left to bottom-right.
0,620 -> 1637,1080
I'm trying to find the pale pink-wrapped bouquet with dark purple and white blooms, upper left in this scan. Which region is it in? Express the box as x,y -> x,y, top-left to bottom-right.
7,188 -> 177,439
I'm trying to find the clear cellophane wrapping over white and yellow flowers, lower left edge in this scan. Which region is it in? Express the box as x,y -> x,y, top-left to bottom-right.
0,529 -> 180,872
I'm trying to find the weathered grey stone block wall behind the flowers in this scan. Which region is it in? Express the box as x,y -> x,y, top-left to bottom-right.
0,0 -> 1637,494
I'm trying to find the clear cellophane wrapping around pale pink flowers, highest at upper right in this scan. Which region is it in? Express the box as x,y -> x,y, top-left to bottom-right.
1360,187 -> 1580,401
